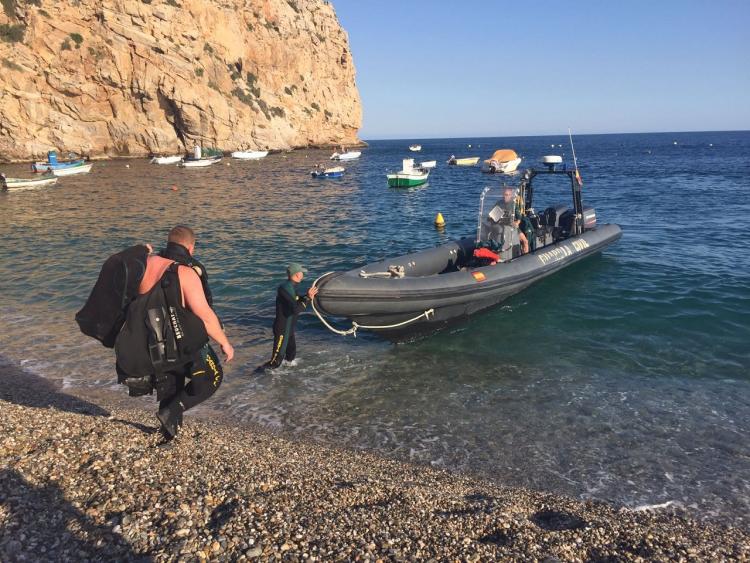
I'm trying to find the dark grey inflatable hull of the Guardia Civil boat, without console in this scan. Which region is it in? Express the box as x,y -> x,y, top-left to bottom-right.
316,225 -> 622,340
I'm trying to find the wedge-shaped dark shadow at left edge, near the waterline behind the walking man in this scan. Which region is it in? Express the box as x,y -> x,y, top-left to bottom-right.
0,356 -> 109,416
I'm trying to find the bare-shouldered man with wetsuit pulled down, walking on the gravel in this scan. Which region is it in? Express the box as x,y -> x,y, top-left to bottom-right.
133,226 -> 234,441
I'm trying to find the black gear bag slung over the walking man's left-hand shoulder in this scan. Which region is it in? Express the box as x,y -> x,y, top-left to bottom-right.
75,245 -> 148,348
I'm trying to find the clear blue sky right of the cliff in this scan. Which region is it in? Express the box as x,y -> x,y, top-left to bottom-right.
333,0 -> 750,139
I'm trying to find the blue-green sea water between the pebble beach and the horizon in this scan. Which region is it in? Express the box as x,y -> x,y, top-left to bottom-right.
0,132 -> 750,525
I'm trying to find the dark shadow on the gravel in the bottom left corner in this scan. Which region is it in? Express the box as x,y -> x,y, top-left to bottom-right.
0,469 -> 151,561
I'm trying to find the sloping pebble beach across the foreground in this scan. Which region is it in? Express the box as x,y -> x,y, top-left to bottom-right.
0,364 -> 750,563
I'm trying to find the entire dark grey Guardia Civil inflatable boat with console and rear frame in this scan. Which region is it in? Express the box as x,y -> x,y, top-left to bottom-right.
316,157 -> 622,340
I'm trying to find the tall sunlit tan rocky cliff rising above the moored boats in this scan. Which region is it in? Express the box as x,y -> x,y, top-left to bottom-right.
0,0 -> 361,161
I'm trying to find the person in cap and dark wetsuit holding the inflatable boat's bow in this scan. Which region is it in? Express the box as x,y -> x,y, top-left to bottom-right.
262,263 -> 318,369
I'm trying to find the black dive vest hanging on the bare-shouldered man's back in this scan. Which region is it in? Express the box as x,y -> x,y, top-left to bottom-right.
115,263 -> 208,378
